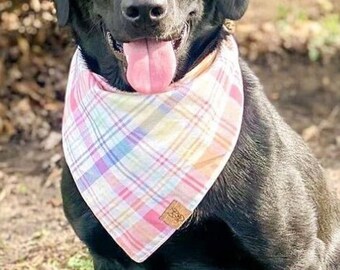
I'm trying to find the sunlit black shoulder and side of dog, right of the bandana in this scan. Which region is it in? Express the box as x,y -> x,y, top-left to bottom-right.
207,63 -> 340,270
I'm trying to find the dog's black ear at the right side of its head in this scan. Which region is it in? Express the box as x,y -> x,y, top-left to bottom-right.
217,0 -> 249,20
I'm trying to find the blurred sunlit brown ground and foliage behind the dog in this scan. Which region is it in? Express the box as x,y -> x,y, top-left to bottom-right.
0,0 -> 340,270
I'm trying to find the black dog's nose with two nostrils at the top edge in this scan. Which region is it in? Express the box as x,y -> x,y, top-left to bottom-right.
121,0 -> 168,23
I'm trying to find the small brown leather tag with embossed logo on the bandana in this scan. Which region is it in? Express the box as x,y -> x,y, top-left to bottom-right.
160,201 -> 192,230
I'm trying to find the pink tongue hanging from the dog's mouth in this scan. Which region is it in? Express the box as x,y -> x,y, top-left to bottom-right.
124,39 -> 177,94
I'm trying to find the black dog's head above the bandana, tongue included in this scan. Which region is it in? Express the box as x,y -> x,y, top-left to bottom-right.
56,0 -> 248,93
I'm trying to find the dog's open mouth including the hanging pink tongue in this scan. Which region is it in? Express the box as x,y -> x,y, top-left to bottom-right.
103,23 -> 190,94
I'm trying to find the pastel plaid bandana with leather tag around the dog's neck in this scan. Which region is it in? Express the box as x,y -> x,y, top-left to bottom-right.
63,33 -> 243,262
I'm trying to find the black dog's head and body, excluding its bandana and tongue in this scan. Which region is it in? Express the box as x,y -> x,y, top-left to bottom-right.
56,0 -> 340,270
